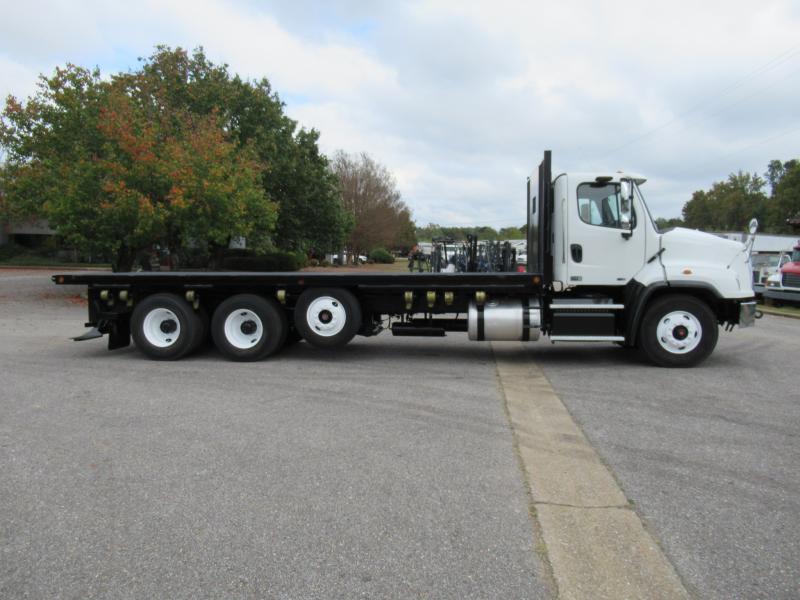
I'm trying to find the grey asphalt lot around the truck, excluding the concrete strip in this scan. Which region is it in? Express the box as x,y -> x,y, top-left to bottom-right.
0,271 -> 800,598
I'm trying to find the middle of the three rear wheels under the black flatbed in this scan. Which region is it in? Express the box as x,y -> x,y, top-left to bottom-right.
211,294 -> 289,361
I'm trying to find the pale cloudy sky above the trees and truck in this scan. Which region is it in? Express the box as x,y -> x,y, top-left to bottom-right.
0,0 -> 800,228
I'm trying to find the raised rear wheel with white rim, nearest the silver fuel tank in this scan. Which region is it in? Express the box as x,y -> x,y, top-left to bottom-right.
294,288 -> 361,348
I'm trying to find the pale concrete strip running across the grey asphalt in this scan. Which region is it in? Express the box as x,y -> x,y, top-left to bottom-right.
492,343 -> 690,599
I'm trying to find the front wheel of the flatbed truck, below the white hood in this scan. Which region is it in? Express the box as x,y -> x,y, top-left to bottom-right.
639,295 -> 718,367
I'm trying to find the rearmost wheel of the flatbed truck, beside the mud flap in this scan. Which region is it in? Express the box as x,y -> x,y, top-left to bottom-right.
131,294 -> 202,360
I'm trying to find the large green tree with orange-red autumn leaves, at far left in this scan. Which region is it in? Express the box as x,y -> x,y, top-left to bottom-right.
0,65 -> 277,270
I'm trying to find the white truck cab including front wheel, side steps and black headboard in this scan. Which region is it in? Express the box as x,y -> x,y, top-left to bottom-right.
528,153 -> 757,366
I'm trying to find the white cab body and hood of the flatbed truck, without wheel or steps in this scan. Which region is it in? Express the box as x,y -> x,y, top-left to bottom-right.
552,173 -> 754,299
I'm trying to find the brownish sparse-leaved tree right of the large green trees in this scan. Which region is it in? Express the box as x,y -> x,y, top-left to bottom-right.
331,150 -> 416,255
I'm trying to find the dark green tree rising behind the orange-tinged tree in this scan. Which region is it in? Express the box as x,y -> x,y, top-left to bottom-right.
120,46 -> 353,253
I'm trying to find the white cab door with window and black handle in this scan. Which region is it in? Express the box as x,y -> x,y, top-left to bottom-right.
566,177 -> 646,286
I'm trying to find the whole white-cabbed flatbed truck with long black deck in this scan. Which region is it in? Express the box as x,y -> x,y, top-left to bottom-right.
53,151 -> 756,367
